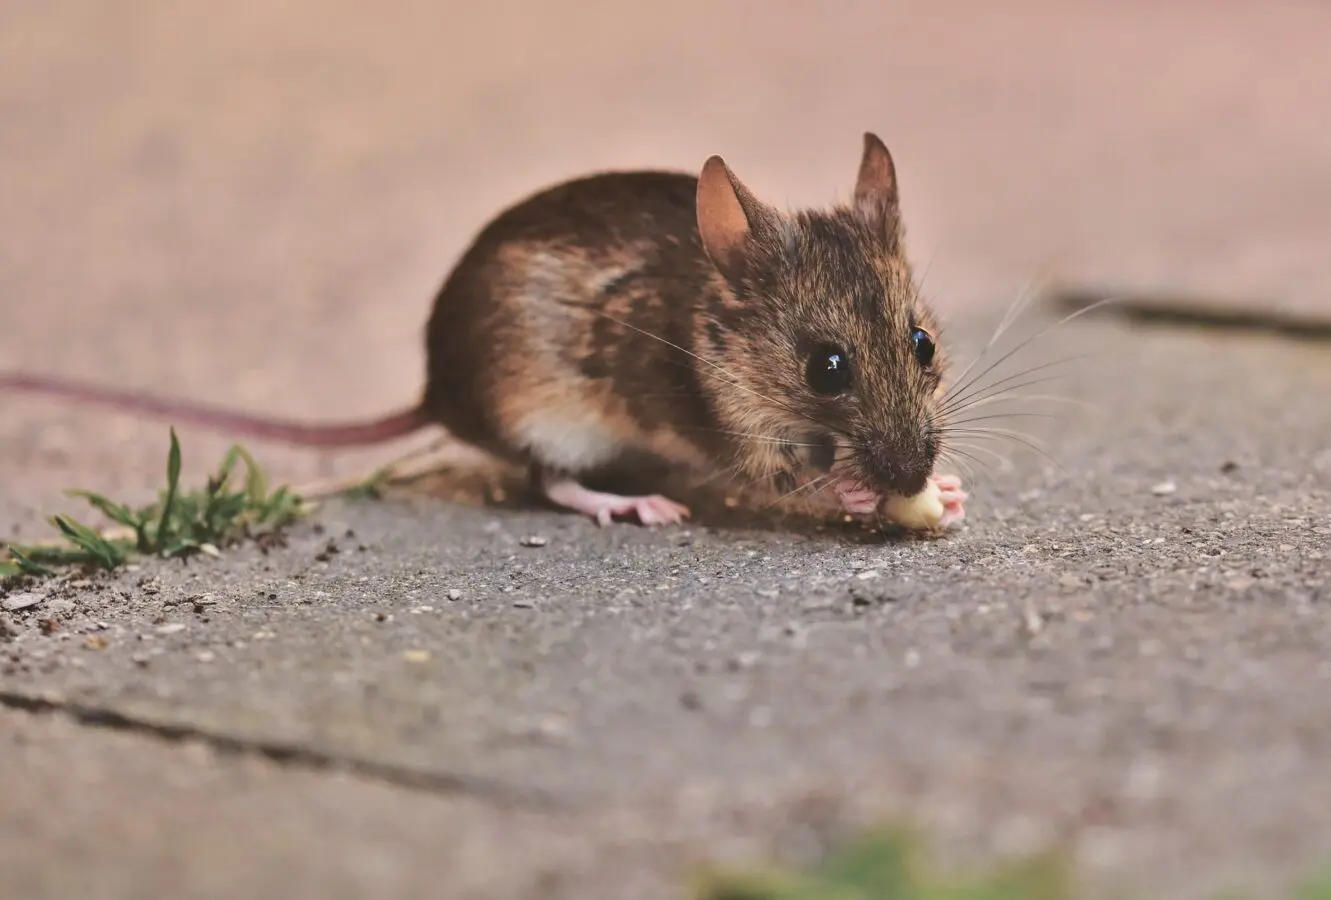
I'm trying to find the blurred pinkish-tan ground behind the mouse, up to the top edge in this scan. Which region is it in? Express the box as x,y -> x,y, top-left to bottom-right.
0,0 -> 1331,521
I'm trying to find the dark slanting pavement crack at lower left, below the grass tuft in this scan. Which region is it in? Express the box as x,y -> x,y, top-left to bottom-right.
0,690 -> 566,812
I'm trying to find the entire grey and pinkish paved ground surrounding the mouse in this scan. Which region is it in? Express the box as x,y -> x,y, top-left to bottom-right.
0,0 -> 1331,897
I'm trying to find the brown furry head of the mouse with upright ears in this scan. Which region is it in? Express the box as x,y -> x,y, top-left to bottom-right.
695,134 -> 944,495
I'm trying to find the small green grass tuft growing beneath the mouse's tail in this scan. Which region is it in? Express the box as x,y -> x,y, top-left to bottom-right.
0,429 -> 305,578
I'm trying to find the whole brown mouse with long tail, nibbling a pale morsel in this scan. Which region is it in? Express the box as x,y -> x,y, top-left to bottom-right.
0,132 -> 966,529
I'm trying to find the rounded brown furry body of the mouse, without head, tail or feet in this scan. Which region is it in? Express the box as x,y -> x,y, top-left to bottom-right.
426,172 -> 717,470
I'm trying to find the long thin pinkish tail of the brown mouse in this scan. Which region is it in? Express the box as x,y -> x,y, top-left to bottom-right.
0,371 -> 430,447
